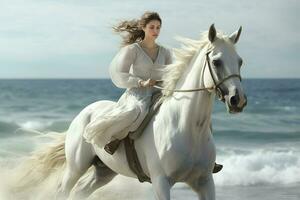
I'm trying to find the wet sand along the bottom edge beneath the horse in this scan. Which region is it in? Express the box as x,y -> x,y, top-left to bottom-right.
88,176 -> 300,200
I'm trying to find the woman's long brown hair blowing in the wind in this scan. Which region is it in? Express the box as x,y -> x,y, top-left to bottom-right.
113,11 -> 162,46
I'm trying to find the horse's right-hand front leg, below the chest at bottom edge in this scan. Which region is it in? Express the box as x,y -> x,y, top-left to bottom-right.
188,175 -> 215,200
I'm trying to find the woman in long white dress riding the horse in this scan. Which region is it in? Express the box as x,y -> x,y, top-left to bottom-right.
84,12 -> 222,173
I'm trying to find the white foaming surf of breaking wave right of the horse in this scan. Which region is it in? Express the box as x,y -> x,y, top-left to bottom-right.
214,148 -> 300,186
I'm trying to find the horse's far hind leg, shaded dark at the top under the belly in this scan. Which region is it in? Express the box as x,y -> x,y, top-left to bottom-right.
71,157 -> 117,199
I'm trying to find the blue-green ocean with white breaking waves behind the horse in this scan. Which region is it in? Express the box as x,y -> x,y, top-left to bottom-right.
0,79 -> 300,200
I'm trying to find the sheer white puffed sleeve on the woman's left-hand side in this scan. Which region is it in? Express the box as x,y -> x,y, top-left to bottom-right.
109,45 -> 142,88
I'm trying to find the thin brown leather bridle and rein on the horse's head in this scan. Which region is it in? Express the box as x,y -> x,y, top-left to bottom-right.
153,51 -> 242,101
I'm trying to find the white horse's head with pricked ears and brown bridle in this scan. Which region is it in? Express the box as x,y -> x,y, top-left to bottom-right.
203,25 -> 247,113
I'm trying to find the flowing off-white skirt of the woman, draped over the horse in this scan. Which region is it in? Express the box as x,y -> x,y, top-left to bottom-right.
83,88 -> 154,145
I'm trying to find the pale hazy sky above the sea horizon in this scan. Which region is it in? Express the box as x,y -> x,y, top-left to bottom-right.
0,0 -> 300,79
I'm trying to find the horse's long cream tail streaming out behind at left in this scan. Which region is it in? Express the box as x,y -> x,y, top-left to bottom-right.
13,133 -> 66,193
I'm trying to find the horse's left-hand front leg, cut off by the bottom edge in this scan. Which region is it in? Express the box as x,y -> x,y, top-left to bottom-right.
151,176 -> 171,200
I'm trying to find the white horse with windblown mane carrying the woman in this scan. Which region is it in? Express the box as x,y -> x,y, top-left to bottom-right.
16,25 -> 247,200
